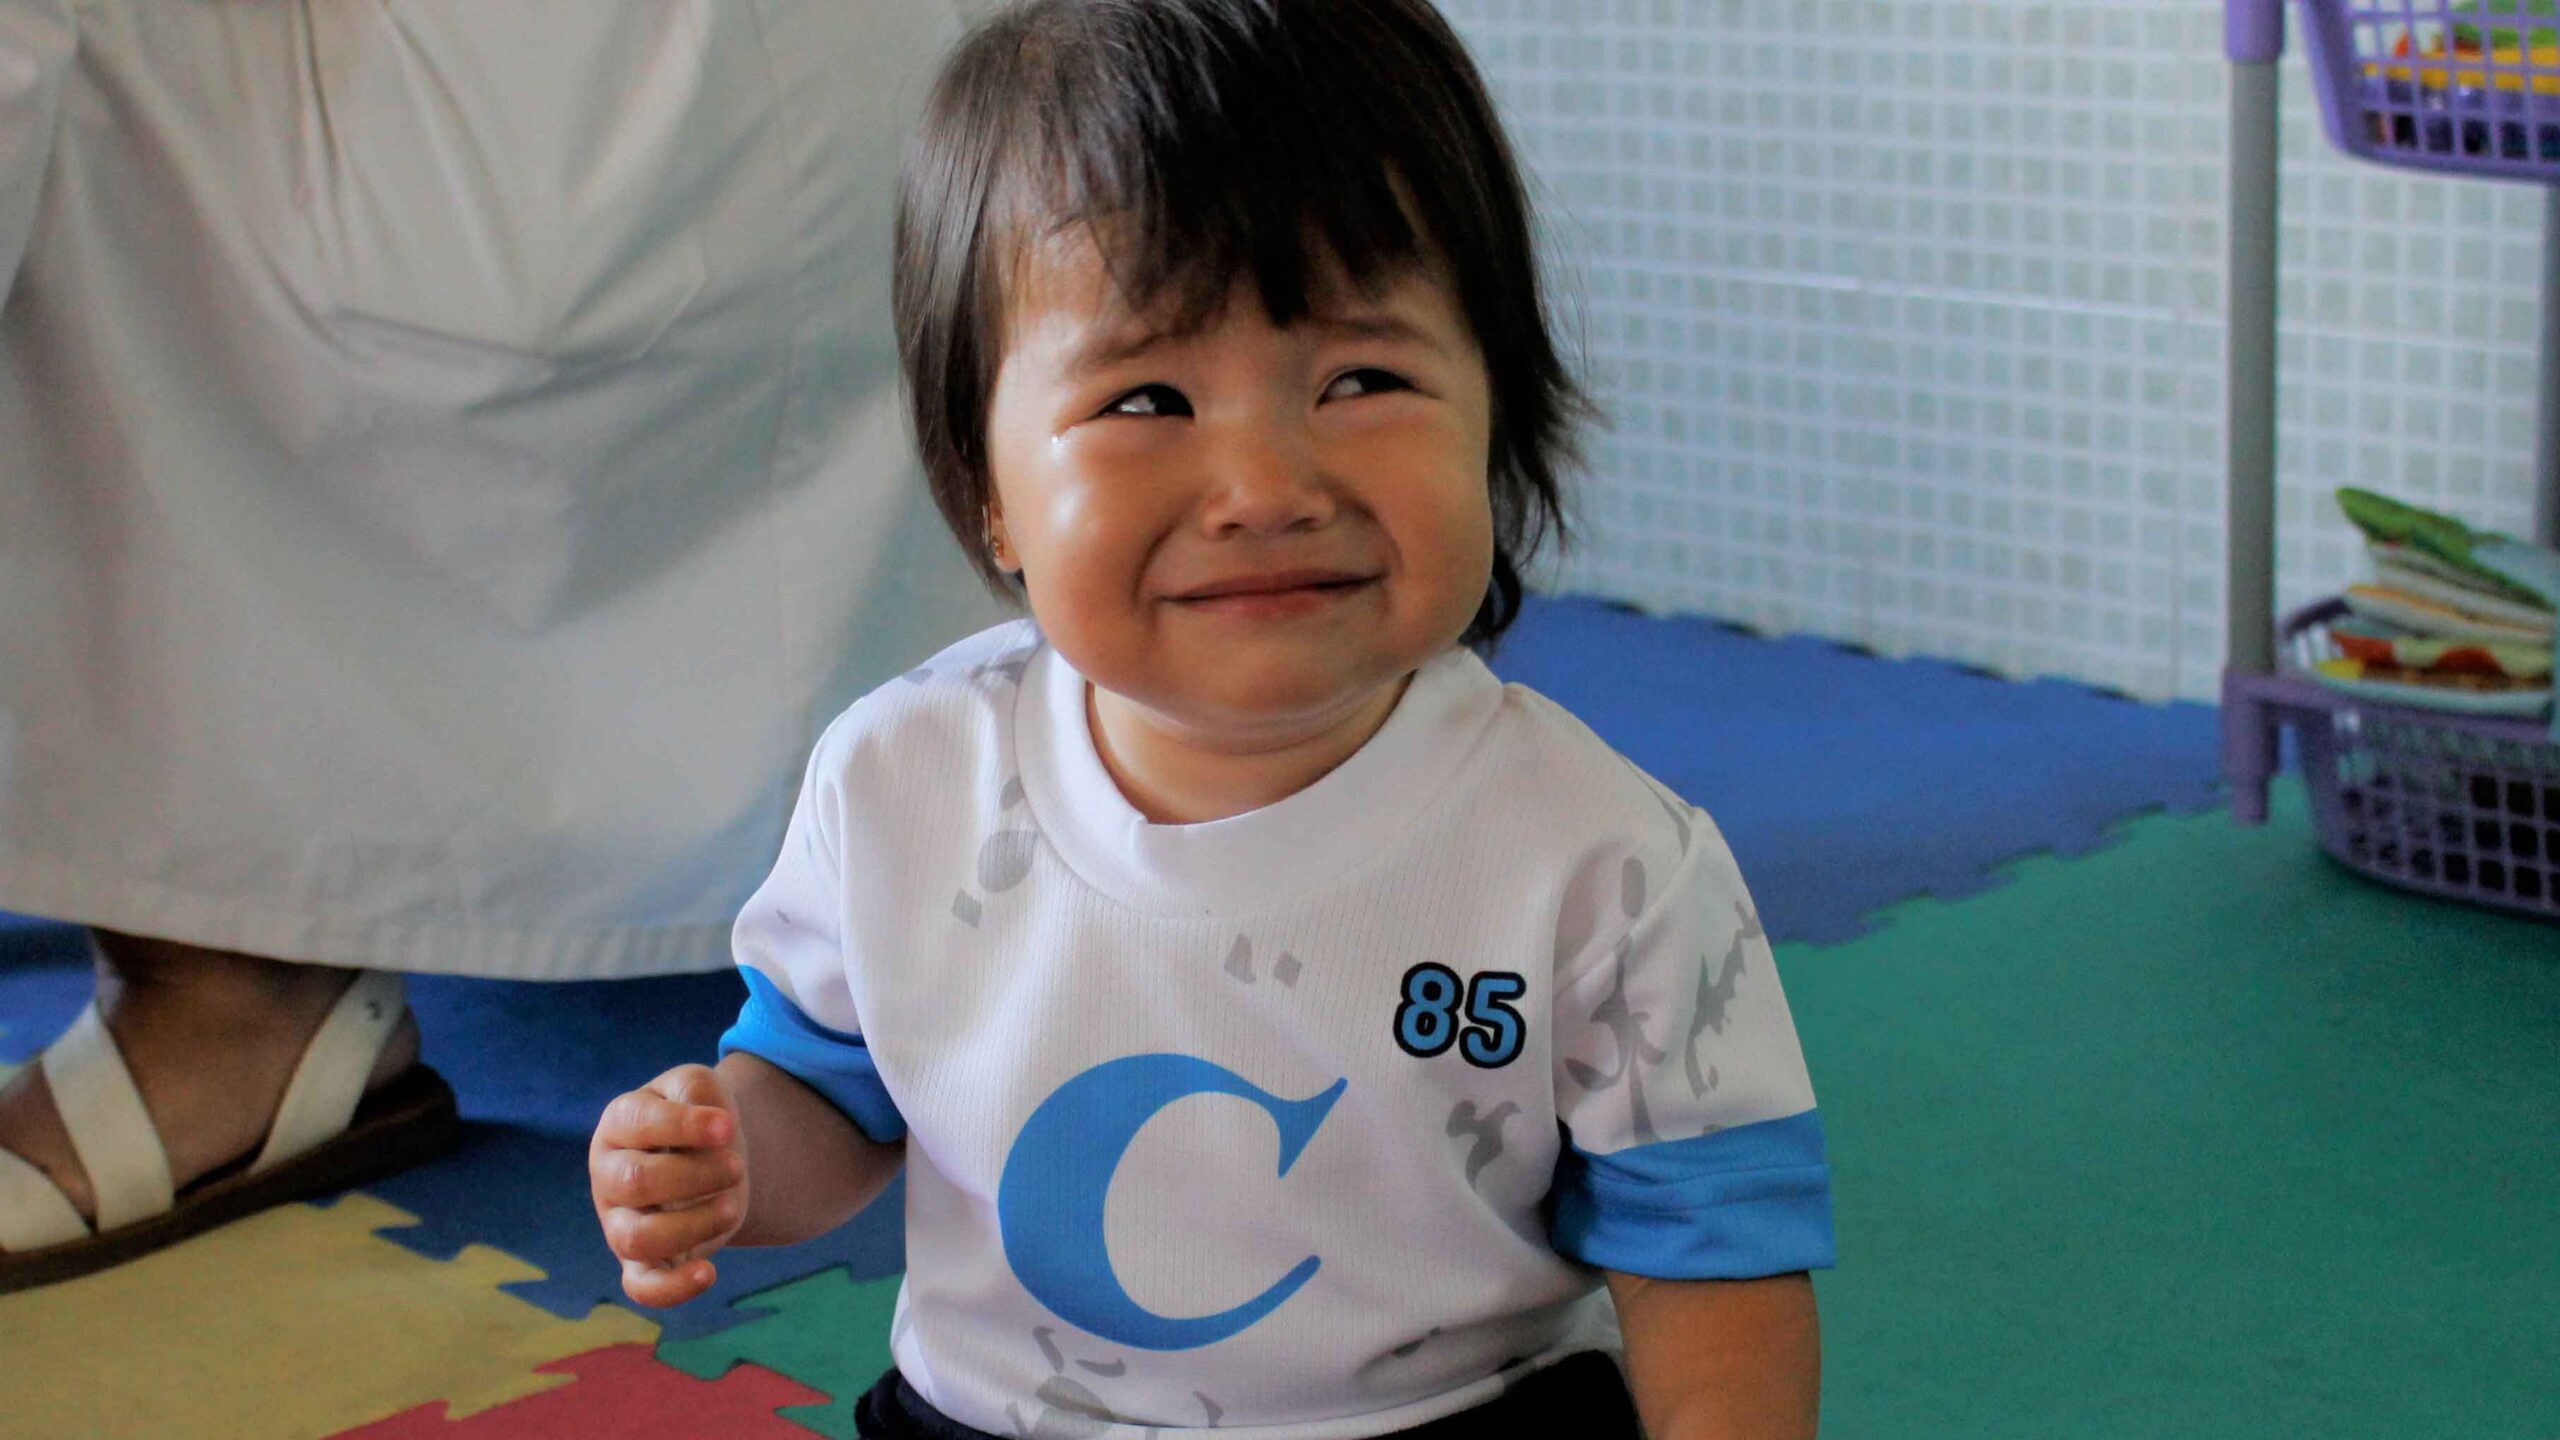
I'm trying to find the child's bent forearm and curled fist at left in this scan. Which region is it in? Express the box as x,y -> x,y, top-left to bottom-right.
586,1053 -> 906,1304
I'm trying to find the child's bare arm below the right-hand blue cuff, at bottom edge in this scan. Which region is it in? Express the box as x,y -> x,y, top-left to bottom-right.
1608,1271 -> 1823,1440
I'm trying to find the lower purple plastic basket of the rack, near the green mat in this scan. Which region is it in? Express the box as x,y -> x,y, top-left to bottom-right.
2222,600 -> 2560,920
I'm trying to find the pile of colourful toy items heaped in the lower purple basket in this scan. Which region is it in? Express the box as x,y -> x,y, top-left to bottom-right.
2312,489 -> 2560,715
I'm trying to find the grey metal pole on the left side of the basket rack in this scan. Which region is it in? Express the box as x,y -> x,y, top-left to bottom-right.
2225,59 -> 2278,674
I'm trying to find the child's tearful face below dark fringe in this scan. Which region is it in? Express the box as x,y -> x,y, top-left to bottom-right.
986,229 -> 1492,746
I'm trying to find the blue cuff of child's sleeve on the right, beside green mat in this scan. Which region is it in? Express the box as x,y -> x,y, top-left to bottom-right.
1551,1109 -> 1836,1281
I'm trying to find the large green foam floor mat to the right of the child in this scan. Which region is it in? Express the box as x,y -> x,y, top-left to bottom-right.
1779,784 -> 2560,1440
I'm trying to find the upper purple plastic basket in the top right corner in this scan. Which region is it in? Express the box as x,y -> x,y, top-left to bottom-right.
2299,0 -> 2560,182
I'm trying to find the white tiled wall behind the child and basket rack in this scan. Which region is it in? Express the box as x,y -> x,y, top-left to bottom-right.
1444,0 -> 2542,697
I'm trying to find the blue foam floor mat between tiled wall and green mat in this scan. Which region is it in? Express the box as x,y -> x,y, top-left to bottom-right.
1492,600 -> 2222,945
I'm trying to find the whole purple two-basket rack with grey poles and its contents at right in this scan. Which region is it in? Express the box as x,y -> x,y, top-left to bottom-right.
2222,0 -> 2560,920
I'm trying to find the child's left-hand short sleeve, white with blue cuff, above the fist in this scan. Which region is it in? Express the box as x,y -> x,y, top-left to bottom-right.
719,722 -> 906,1145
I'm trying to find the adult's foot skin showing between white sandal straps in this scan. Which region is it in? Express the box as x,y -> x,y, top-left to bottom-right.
0,930 -> 417,1222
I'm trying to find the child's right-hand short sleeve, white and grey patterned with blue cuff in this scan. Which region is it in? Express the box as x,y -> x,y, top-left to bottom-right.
1551,810 -> 1833,1279
